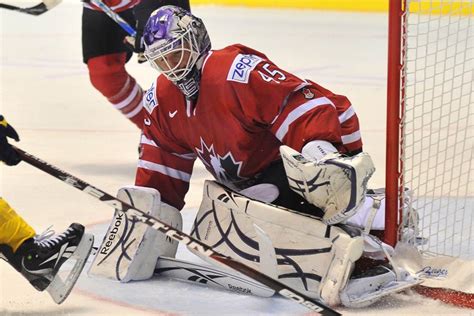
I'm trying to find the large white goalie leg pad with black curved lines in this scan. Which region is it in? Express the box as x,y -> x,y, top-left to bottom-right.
190,181 -> 363,302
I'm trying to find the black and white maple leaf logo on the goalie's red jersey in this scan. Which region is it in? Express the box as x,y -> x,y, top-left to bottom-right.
196,138 -> 244,183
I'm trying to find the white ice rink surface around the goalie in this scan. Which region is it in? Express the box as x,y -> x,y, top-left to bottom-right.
0,0 -> 471,315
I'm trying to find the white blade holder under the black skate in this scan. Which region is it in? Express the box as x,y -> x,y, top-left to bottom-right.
46,234 -> 94,304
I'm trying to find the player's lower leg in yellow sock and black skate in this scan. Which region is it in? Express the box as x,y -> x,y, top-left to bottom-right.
0,198 -> 94,304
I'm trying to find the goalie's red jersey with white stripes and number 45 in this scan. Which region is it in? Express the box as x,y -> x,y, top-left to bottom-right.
136,45 -> 362,209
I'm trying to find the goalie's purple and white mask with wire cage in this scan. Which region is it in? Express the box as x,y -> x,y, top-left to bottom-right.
143,6 -> 211,99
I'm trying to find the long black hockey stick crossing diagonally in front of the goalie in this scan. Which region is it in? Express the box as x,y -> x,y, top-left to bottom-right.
12,146 -> 341,316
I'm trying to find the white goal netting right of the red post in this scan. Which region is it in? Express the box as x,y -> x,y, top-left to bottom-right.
401,0 -> 474,259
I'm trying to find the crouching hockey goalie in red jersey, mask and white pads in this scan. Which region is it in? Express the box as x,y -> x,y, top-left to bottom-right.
91,6 -> 419,307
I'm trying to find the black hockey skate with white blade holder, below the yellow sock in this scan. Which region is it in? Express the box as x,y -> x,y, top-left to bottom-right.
0,223 -> 93,304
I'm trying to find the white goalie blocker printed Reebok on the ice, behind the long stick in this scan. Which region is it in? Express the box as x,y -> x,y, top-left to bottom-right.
89,186 -> 183,282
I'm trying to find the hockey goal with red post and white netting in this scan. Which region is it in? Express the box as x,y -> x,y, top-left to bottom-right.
385,0 -> 474,307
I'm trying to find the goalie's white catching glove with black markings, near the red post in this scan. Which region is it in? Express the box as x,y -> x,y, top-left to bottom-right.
280,141 -> 375,225
